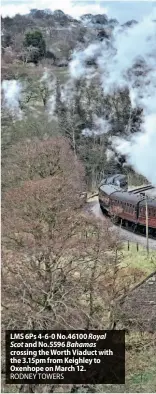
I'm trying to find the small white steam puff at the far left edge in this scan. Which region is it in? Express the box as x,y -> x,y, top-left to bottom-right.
2,79 -> 22,116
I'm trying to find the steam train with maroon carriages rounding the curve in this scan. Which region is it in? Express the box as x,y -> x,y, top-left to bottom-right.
99,174 -> 156,238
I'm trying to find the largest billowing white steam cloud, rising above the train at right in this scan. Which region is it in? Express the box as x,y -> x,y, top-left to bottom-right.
70,9 -> 156,185
